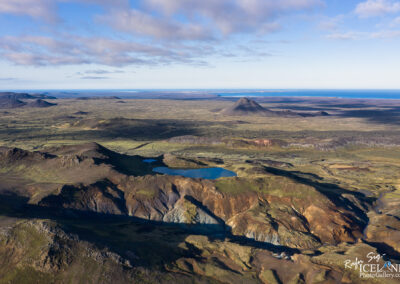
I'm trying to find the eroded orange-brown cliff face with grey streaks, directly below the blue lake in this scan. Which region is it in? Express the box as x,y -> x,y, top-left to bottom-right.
39,176 -> 365,249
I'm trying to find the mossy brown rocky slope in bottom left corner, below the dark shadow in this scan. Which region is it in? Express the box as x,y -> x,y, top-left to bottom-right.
0,220 -> 196,283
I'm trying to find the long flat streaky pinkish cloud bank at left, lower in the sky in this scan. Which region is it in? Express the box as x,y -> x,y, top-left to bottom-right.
0,35 -> 217,66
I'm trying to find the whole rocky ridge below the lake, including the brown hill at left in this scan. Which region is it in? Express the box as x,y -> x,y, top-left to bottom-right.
0,144 -> 365,248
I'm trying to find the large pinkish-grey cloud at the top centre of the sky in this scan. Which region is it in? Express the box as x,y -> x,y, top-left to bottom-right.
99,0 -> 322,40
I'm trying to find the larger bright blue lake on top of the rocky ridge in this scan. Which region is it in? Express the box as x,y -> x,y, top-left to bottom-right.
153,167 -> 237,179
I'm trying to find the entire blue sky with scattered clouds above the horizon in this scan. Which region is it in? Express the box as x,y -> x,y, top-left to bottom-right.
0,0 -> 400,90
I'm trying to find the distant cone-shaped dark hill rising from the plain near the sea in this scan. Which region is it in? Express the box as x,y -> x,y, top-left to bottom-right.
221,98 -> 329,117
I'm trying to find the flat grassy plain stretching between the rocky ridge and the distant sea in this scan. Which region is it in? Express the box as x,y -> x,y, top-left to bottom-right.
0,96 -> 400,196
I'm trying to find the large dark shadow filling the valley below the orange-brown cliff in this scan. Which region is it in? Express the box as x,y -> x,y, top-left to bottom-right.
0,194 -> 299,269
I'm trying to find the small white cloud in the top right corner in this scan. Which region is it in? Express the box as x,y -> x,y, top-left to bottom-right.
355,0 -> 400,18
